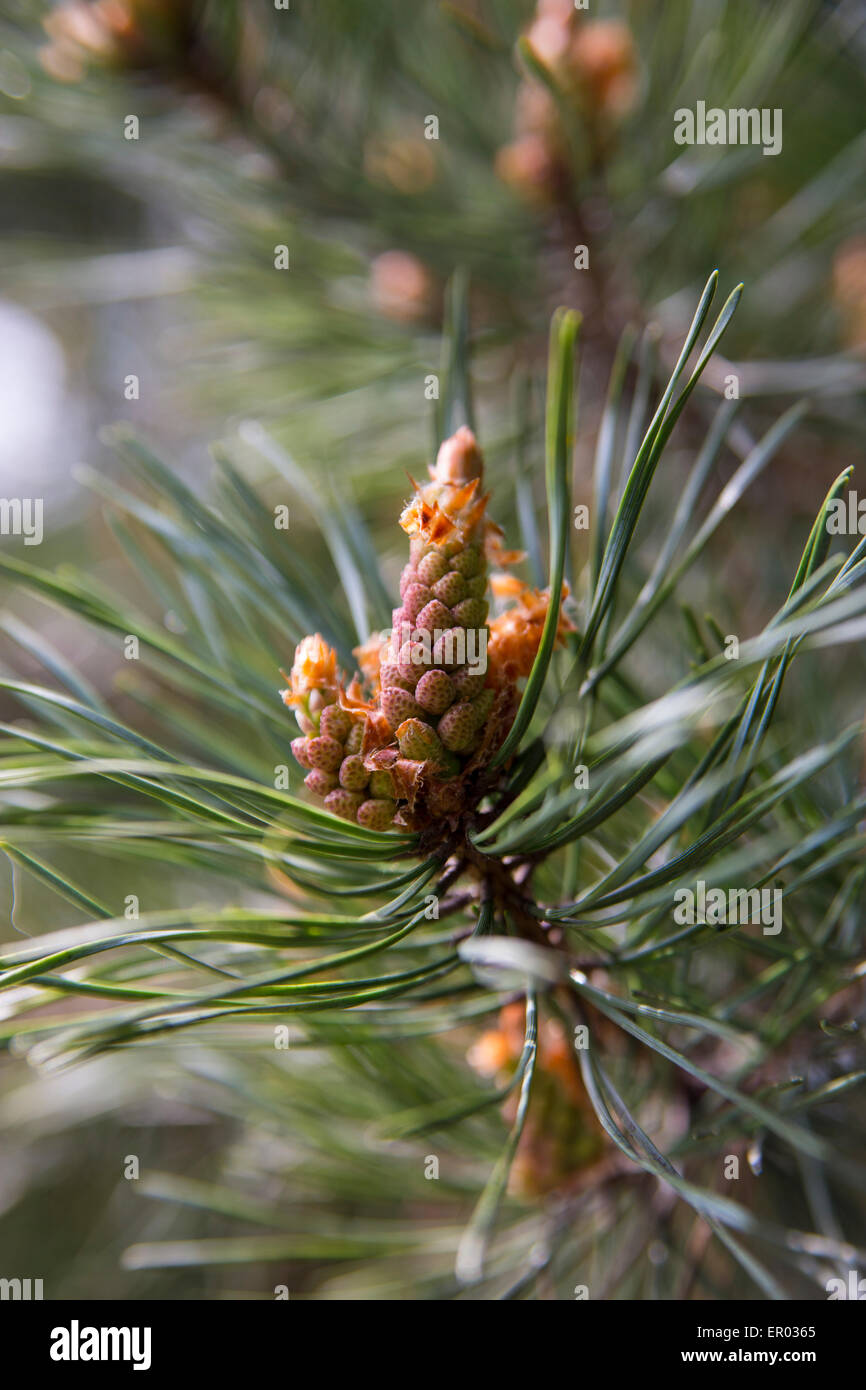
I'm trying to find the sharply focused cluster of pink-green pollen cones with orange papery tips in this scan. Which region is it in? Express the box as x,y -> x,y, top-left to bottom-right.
282,425 -> 570,830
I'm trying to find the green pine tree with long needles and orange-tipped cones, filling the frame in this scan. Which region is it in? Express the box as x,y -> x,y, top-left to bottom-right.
0,0 -> 866,1300
